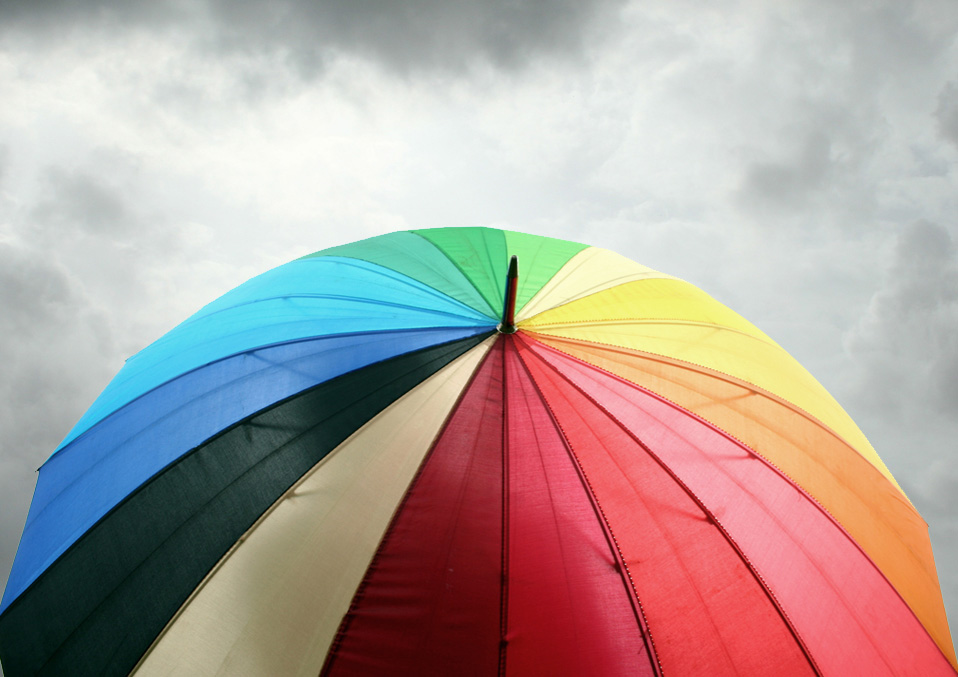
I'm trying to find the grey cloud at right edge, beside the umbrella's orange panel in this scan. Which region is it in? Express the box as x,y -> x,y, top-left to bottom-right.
845,221 -> 958,624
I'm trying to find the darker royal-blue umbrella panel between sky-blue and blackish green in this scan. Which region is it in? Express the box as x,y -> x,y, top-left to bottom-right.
0,328 -> 488,610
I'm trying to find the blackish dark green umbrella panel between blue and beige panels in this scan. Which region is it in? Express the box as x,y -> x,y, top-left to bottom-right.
0,334 -> 496,677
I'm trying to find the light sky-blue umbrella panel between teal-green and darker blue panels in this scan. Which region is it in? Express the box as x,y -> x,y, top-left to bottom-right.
59,257 -> 495,449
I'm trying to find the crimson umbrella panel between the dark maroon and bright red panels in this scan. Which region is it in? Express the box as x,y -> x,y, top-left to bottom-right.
504,339 -> 654,675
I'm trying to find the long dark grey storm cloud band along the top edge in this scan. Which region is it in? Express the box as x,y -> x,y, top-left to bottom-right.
0,0 -> 624,75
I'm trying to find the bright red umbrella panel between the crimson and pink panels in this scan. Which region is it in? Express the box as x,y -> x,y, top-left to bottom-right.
520,339 -> 816,676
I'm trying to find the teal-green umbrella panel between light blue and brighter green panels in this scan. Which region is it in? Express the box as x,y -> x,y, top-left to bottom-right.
303,231 -> 502,319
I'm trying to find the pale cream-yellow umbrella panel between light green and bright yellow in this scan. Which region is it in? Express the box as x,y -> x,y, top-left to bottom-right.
516,247 -> 672,322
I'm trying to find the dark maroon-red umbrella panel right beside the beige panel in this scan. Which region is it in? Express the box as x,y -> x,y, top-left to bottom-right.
326,341 -> 503,675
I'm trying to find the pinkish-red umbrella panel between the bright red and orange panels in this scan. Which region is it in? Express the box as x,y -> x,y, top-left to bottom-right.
527,342 -> 954,675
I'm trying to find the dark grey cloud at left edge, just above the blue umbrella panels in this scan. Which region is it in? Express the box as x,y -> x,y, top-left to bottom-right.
0,242 -> 112,616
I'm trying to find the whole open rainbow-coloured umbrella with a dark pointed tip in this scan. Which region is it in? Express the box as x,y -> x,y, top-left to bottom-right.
0,228 -> 955,676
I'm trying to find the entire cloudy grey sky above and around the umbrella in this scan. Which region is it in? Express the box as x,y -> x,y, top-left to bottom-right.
0,0 -> 958,656
